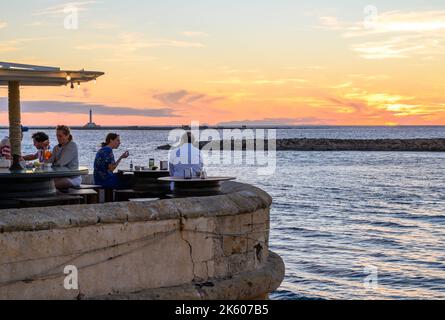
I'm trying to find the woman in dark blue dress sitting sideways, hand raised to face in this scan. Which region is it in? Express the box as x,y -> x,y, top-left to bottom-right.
94,133 -> 130,189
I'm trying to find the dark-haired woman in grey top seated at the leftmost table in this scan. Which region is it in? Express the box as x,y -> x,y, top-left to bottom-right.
50,126 -> 82,190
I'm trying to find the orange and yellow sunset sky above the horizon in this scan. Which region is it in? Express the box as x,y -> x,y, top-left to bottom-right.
0,0 -> 445,125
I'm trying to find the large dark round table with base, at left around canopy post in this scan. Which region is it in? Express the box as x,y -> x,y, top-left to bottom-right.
0,167 -> 88,208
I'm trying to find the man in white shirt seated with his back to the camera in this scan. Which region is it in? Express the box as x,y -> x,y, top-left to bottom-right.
168,132 -> 204,190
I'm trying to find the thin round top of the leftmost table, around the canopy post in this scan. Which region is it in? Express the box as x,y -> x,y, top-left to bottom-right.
0,167 -> 89,179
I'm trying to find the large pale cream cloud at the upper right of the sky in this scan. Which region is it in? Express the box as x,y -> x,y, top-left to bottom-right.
320,10 -> 445,60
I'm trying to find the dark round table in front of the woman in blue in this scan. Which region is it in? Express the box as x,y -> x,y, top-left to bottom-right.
119,170 -> 170,195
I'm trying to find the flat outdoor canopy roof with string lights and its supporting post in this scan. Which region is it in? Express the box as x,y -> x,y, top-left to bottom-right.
0,62 -> 104,170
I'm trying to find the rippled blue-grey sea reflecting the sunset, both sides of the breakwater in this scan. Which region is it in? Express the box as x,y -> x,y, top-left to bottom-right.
0,127 -> 445,299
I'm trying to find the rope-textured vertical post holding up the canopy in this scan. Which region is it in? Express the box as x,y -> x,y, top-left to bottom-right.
8,81 -> 24,170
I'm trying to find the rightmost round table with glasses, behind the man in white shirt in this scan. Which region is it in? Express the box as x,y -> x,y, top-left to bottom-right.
159,177 -> 236,197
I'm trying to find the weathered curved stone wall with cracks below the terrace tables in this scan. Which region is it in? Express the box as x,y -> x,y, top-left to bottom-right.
0,182 -> 284,299
